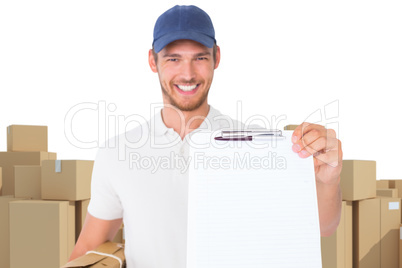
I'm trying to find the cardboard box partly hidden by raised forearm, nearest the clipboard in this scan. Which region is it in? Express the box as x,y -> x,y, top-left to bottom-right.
321,201 -> 353,268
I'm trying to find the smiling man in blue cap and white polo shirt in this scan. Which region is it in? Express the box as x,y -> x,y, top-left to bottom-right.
70,6 -> 342,268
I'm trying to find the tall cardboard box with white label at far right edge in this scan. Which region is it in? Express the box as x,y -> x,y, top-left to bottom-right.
380,198 -> 401,268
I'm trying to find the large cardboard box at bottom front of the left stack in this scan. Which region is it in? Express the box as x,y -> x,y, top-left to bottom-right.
9,200 -> 75,268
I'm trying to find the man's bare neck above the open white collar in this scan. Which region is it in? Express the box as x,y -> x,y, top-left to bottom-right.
162,102 -> 209,140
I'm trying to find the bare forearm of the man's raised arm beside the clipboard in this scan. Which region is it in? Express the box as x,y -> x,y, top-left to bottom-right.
317,176 -> 342,236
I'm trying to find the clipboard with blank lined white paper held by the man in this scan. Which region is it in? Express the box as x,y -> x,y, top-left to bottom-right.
187,130 -> 322,268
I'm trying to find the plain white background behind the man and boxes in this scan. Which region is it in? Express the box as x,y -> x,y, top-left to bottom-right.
0,0 -> 402,179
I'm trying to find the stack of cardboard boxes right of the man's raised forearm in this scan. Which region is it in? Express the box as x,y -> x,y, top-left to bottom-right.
285,125 -> 402,268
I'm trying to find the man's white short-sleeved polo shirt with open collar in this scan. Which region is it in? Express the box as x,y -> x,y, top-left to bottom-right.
88,106 -> 242,268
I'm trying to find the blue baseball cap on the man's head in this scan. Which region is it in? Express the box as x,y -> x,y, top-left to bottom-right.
152,5 -> 216,53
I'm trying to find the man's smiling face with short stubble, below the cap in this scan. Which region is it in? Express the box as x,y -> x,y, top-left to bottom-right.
149,40 -> 220,111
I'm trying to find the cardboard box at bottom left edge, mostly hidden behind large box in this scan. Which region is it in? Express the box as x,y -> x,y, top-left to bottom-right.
0,196 -> 27,268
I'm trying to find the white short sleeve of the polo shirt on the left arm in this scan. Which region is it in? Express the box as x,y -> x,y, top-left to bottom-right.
88,148 -> 123,220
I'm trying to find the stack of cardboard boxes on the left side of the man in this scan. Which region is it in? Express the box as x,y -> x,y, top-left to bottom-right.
0,125 -> 122,268
